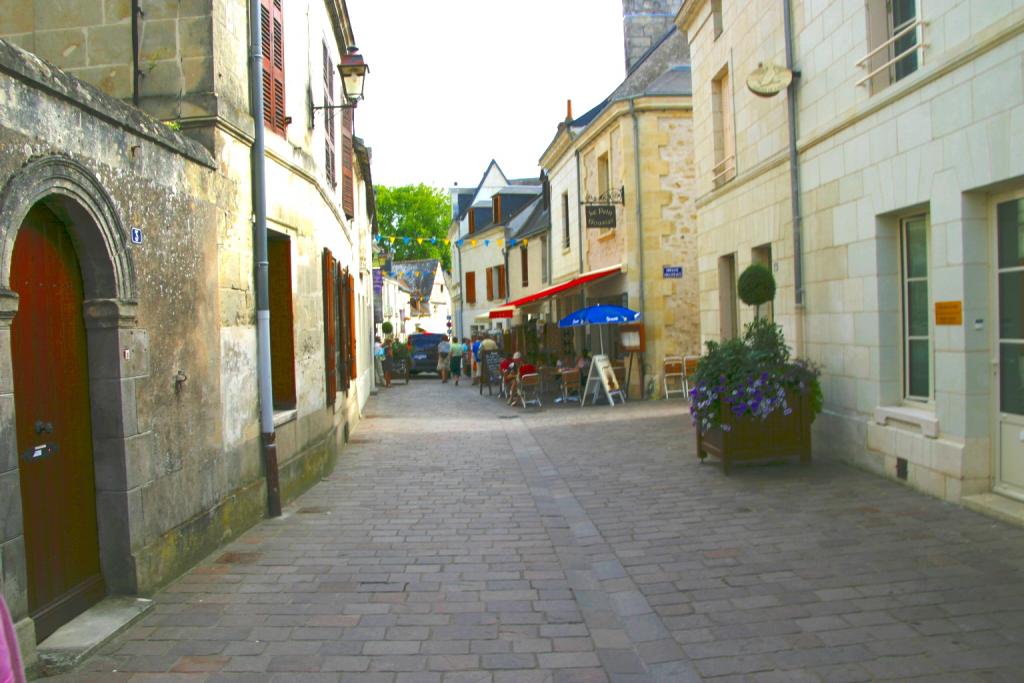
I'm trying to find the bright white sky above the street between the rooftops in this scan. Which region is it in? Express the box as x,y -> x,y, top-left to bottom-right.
347,0 -> 626,192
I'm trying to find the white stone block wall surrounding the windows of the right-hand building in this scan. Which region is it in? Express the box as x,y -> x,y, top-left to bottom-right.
686,0 -> 1024,501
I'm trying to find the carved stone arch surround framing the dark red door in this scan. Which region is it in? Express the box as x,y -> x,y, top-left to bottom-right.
0,156 -> 147,634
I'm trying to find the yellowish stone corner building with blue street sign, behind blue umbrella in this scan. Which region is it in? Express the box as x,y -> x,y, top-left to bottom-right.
572,27 -> 698,395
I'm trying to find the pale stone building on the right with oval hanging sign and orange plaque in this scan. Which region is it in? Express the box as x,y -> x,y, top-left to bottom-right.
677,0 -> 1024,518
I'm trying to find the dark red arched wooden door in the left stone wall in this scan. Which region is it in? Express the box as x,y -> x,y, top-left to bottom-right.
10,206 -> 105,640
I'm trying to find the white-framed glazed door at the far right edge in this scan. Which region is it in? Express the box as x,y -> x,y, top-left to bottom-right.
994,197 -> 1024,500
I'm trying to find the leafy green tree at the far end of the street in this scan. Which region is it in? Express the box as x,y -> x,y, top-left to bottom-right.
374,187 -> 452,270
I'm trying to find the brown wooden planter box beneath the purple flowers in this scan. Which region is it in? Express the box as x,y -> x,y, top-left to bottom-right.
697,394 -> 812,474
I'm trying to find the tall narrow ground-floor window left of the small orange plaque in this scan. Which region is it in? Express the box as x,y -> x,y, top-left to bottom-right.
900,216 -> 932,401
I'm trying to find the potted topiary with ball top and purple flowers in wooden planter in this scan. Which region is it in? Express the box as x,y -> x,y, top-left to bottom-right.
690,266 -> 822,474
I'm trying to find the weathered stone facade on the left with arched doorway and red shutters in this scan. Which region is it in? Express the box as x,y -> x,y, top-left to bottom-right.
0,0 -> 374,660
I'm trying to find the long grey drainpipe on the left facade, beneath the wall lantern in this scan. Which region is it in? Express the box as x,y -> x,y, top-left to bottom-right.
249,0 -> 281,517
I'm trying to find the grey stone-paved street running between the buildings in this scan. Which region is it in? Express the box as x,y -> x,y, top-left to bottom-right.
54,379 -> 1024,683
